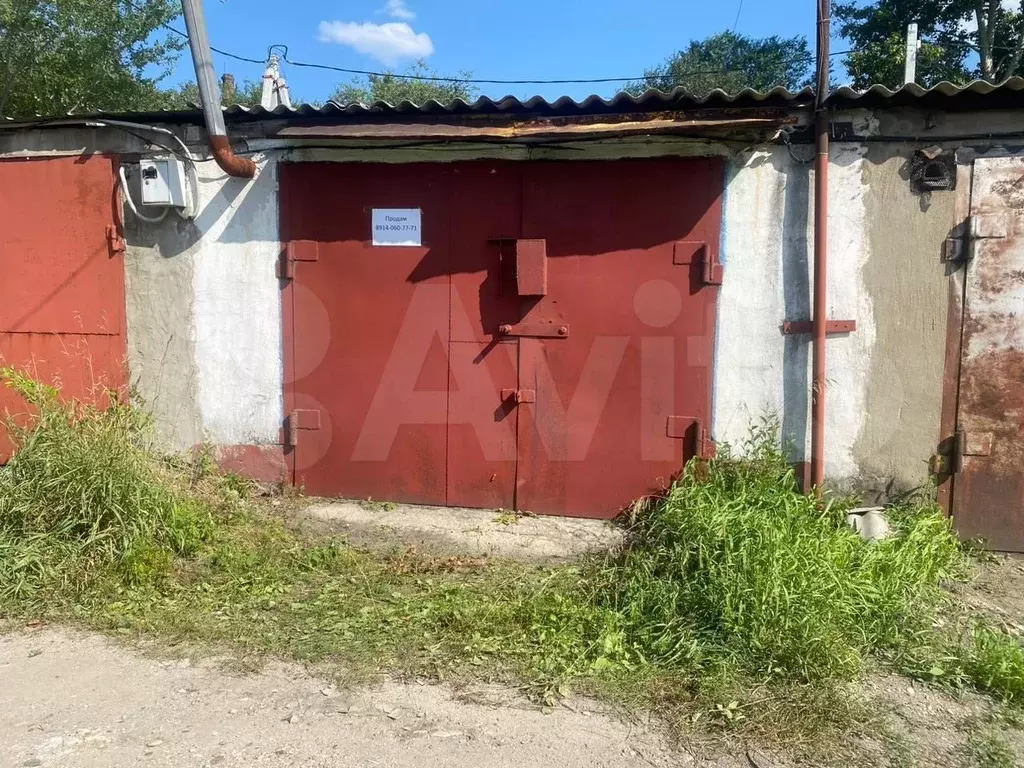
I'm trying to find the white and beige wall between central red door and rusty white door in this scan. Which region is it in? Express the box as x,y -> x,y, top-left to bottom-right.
715,143 -> 954,499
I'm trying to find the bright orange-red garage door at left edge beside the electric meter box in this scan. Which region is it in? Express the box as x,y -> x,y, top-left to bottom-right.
0,155 -> 125,461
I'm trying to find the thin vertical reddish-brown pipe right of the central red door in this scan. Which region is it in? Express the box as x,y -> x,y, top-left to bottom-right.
811,0 -> 831,495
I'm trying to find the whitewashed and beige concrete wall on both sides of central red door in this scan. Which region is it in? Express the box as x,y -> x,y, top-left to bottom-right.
0,113 -> 954,496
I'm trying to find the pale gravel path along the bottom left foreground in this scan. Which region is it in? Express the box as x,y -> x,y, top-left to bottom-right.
0,628 -> 691,768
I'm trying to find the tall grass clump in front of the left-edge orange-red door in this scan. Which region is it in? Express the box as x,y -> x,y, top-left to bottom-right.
0,369 -> 213,600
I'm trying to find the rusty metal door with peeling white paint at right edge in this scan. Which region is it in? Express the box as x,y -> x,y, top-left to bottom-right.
952,158 -> 1024,552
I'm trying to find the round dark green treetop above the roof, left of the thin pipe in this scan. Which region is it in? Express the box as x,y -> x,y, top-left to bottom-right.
628,32 -> 814,95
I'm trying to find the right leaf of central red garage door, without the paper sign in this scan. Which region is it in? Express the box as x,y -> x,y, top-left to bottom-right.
517,159 -> 723,517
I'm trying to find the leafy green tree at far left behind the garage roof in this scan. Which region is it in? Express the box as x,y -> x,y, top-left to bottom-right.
0,0 -> 183,117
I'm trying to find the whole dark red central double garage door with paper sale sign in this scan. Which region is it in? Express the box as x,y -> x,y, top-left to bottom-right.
281,160 -> 722,517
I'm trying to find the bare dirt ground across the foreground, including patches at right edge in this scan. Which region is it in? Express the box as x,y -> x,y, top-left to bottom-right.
6,540 -> 1024,768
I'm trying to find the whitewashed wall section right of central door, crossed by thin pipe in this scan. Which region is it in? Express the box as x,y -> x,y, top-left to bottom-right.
713,145 -> 874,479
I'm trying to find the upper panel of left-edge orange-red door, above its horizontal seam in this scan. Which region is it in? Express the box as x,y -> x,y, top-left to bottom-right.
0,155 -> 124,336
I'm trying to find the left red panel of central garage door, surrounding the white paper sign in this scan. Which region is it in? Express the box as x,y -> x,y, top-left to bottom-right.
281,163 -> 451,504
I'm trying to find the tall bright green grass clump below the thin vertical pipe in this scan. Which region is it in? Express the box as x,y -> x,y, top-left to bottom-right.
607,424 -> 967,682
